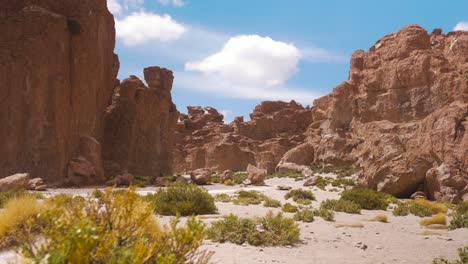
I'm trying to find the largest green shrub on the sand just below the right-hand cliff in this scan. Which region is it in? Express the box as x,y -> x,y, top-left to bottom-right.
340,186 -> 392,210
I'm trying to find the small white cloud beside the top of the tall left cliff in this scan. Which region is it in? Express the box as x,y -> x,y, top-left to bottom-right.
115,10 -> 187,46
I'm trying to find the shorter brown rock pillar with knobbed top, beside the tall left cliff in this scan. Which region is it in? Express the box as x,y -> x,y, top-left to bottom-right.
102,67 -> 178,178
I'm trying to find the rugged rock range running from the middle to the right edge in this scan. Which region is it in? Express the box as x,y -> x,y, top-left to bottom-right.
175,25 -> 468,201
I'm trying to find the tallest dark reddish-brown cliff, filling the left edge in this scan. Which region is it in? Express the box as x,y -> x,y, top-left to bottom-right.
0,0 -> 119,183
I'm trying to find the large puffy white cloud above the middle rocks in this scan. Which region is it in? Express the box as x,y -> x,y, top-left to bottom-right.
185,35 -> 300,86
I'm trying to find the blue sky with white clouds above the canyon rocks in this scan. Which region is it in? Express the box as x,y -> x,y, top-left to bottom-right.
108,0 -> 468,121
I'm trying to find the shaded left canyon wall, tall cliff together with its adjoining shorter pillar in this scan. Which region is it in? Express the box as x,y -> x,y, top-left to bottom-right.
0,0 -> 176,185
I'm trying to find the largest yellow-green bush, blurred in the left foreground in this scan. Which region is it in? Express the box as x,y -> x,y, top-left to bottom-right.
21,189 -> 210,263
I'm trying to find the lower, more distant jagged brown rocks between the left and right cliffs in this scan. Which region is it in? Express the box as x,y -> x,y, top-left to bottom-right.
174,101 -> 312,172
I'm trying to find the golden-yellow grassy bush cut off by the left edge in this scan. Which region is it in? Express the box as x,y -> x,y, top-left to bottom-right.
0,196 -> 44,249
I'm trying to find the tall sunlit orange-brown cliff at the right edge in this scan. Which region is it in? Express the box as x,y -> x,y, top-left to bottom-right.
308,26 -> 468,201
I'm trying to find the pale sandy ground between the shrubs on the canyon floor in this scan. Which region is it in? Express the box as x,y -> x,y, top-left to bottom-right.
0,175 -> 468,264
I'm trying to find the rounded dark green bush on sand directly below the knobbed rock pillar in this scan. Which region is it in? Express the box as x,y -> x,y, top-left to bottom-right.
146,183 -> 217,216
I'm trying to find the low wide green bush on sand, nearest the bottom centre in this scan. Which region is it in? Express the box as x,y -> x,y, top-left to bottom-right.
208,211 -> 300,246
